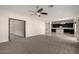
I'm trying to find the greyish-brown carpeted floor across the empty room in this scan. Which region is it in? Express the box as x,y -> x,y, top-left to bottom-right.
0,35 -> 79,54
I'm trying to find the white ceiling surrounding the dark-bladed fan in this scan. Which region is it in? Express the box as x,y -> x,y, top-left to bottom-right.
2,5 -> 79,22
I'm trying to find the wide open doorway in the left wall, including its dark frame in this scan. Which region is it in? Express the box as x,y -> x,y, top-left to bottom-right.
9,18 -> 26,40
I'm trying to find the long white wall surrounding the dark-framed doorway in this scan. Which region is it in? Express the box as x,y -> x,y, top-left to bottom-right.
0,7 -> 45,42
